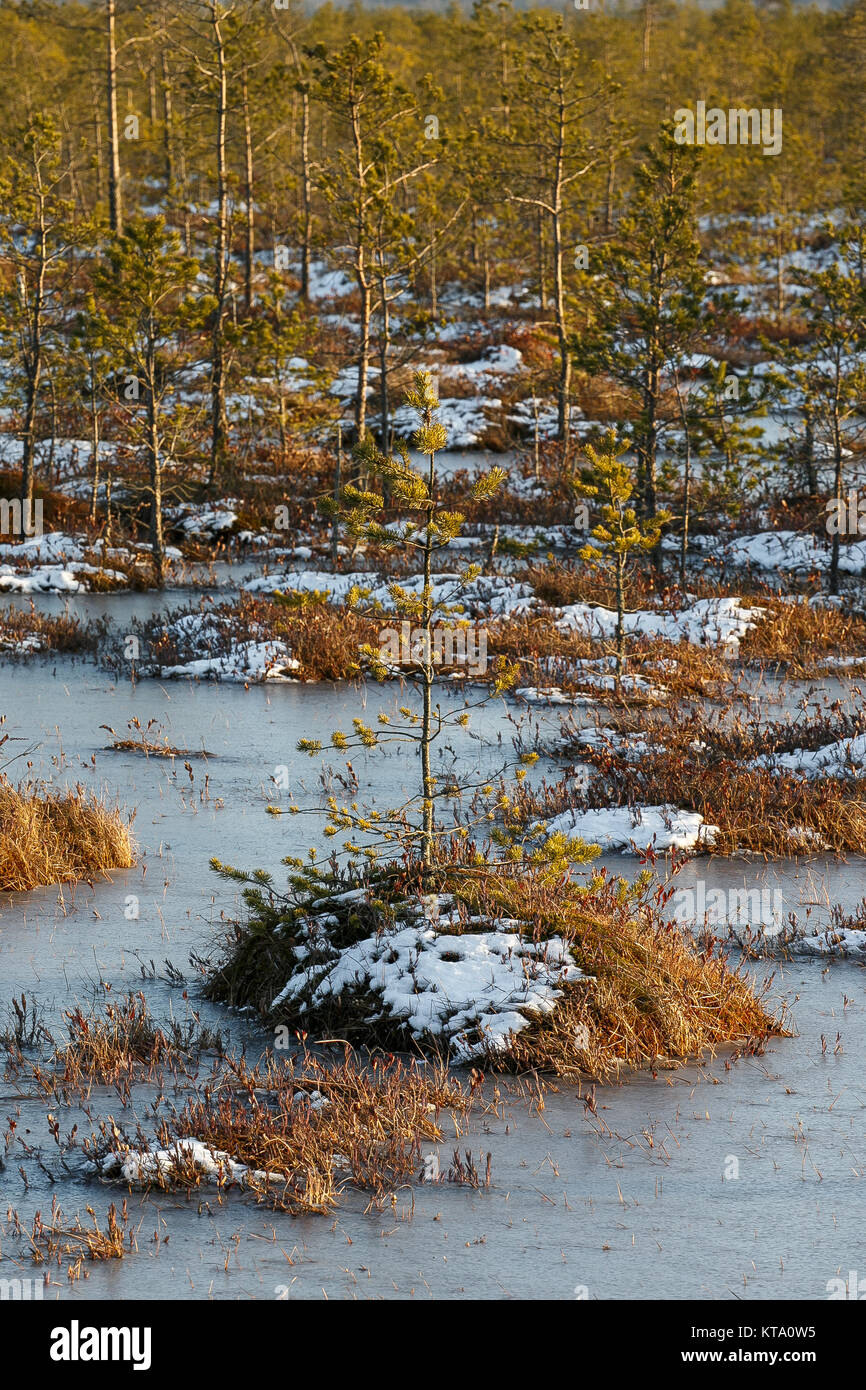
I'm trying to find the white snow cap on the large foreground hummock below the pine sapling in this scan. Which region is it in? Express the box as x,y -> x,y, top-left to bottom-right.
271,899 -> 589,1061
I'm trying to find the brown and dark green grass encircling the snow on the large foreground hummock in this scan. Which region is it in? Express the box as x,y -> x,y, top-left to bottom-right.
201,845 -> 781,1080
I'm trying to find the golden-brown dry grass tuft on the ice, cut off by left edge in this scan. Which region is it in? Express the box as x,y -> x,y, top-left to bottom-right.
0,778 -> 135,892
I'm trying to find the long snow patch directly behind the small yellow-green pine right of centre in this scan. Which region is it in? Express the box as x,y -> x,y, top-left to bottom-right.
556,598 -> 763,655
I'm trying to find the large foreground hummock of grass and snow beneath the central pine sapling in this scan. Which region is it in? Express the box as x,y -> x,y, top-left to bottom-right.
207,845 -> 781,1080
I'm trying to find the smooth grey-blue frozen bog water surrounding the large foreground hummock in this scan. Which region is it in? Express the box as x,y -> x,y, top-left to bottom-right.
0,642 -> 866,1300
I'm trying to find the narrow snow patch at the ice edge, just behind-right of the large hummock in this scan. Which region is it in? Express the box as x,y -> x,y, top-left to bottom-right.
544,806 -> 719,853
